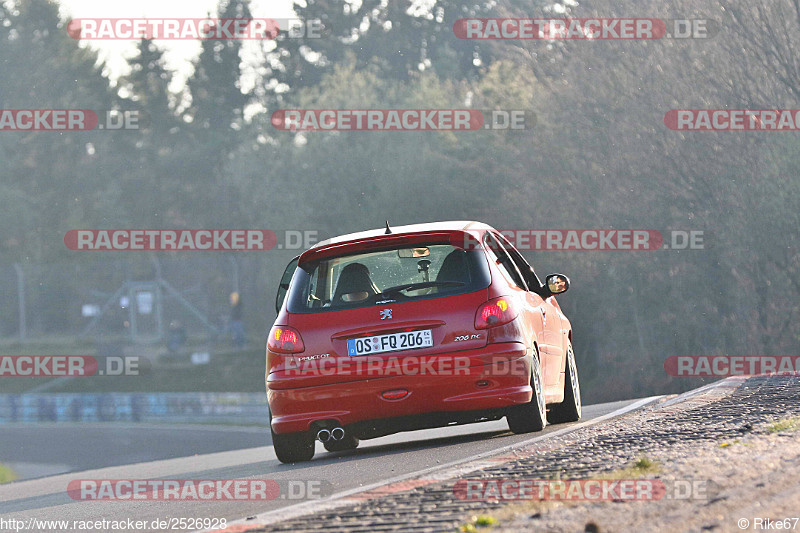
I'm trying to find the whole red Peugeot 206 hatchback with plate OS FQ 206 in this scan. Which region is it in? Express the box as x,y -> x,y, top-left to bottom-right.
266,222 -> 581,463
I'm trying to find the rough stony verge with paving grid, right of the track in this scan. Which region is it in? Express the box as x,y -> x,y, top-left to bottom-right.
240,376 -> 800,533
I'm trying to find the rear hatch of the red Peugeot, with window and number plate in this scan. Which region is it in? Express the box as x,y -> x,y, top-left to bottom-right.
268,233 -> 490,388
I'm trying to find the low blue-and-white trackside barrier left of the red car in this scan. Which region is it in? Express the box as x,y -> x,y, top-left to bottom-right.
0,392 -> 268,425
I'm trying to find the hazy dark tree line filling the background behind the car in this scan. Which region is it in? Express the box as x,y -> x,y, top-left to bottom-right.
0,0 -> 800,400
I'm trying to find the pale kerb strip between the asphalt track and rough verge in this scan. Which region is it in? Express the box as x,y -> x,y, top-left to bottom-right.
212,376 -> 748,533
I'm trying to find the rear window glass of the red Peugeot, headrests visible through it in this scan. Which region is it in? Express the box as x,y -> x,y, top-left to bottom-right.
288,243 -> 490,313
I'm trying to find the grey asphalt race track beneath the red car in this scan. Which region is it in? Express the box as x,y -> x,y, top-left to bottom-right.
0,400 -> 648,529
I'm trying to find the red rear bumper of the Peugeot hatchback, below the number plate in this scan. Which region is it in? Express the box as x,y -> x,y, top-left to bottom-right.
267,343 -> 532,438
